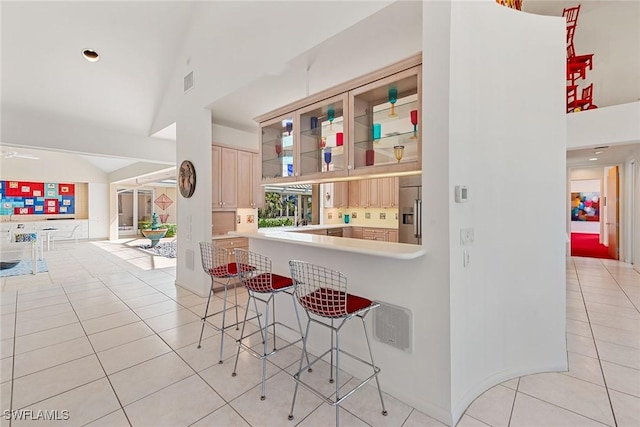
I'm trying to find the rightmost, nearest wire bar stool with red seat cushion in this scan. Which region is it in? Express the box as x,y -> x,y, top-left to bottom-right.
289,260 -> 387,426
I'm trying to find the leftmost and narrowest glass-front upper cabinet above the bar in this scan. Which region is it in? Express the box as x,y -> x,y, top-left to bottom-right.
260,113 -> 298,182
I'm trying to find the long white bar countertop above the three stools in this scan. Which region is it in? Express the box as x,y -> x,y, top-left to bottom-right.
229,231 -> 426,259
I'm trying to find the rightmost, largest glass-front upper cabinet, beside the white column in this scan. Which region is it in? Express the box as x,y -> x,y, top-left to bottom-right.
349,66 -> 422,175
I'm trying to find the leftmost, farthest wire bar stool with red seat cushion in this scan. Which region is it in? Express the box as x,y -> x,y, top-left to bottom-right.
198,242 -> 249,363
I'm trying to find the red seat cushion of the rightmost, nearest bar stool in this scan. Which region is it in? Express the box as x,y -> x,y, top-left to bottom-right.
300,288 -> 373,317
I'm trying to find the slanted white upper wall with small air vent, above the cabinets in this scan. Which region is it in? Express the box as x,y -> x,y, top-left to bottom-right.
152,1 -> 391,135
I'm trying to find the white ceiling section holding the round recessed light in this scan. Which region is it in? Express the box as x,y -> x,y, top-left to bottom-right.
1,1 -> 193,137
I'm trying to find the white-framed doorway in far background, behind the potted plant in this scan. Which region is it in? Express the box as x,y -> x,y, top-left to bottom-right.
118,188 -> 154,238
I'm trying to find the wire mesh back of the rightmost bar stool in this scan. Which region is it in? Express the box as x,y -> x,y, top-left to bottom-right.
289,260 -> 353,318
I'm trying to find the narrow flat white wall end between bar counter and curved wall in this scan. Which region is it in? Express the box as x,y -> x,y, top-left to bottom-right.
420,1 -> 456,425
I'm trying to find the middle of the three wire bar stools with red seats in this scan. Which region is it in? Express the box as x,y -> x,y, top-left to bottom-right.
231,248 -> 308,400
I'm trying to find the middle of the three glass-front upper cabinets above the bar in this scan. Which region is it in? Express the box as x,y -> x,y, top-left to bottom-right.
296,93 -> 349,178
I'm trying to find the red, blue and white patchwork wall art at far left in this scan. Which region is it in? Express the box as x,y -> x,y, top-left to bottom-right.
0,181 -> 75,215
